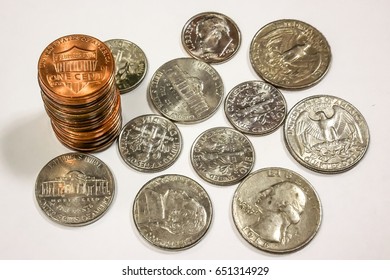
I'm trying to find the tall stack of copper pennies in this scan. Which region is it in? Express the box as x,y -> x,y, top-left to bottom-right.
38,35 -> 122,152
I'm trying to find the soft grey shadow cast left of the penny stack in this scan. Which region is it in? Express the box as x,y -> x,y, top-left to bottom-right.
0,113 -> 64,177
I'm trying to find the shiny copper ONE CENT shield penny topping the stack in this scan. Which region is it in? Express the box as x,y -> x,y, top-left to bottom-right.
38,34 -> 115,103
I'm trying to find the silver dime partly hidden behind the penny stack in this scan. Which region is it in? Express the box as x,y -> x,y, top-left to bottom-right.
104,39 -> 148,94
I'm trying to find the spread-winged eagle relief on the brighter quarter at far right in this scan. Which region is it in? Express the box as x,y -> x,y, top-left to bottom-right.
295,105 -> 363,155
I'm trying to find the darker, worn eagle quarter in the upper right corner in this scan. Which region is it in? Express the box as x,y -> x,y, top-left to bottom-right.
249,19 -> 331,89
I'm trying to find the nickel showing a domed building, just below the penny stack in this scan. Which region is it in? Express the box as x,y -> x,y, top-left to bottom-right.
35,153 -> 115,226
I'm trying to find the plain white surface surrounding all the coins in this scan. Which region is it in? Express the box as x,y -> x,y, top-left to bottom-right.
0,0 -> 390,260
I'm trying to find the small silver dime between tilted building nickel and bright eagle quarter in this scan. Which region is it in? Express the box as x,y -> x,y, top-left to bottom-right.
225,81 -> 287,135
